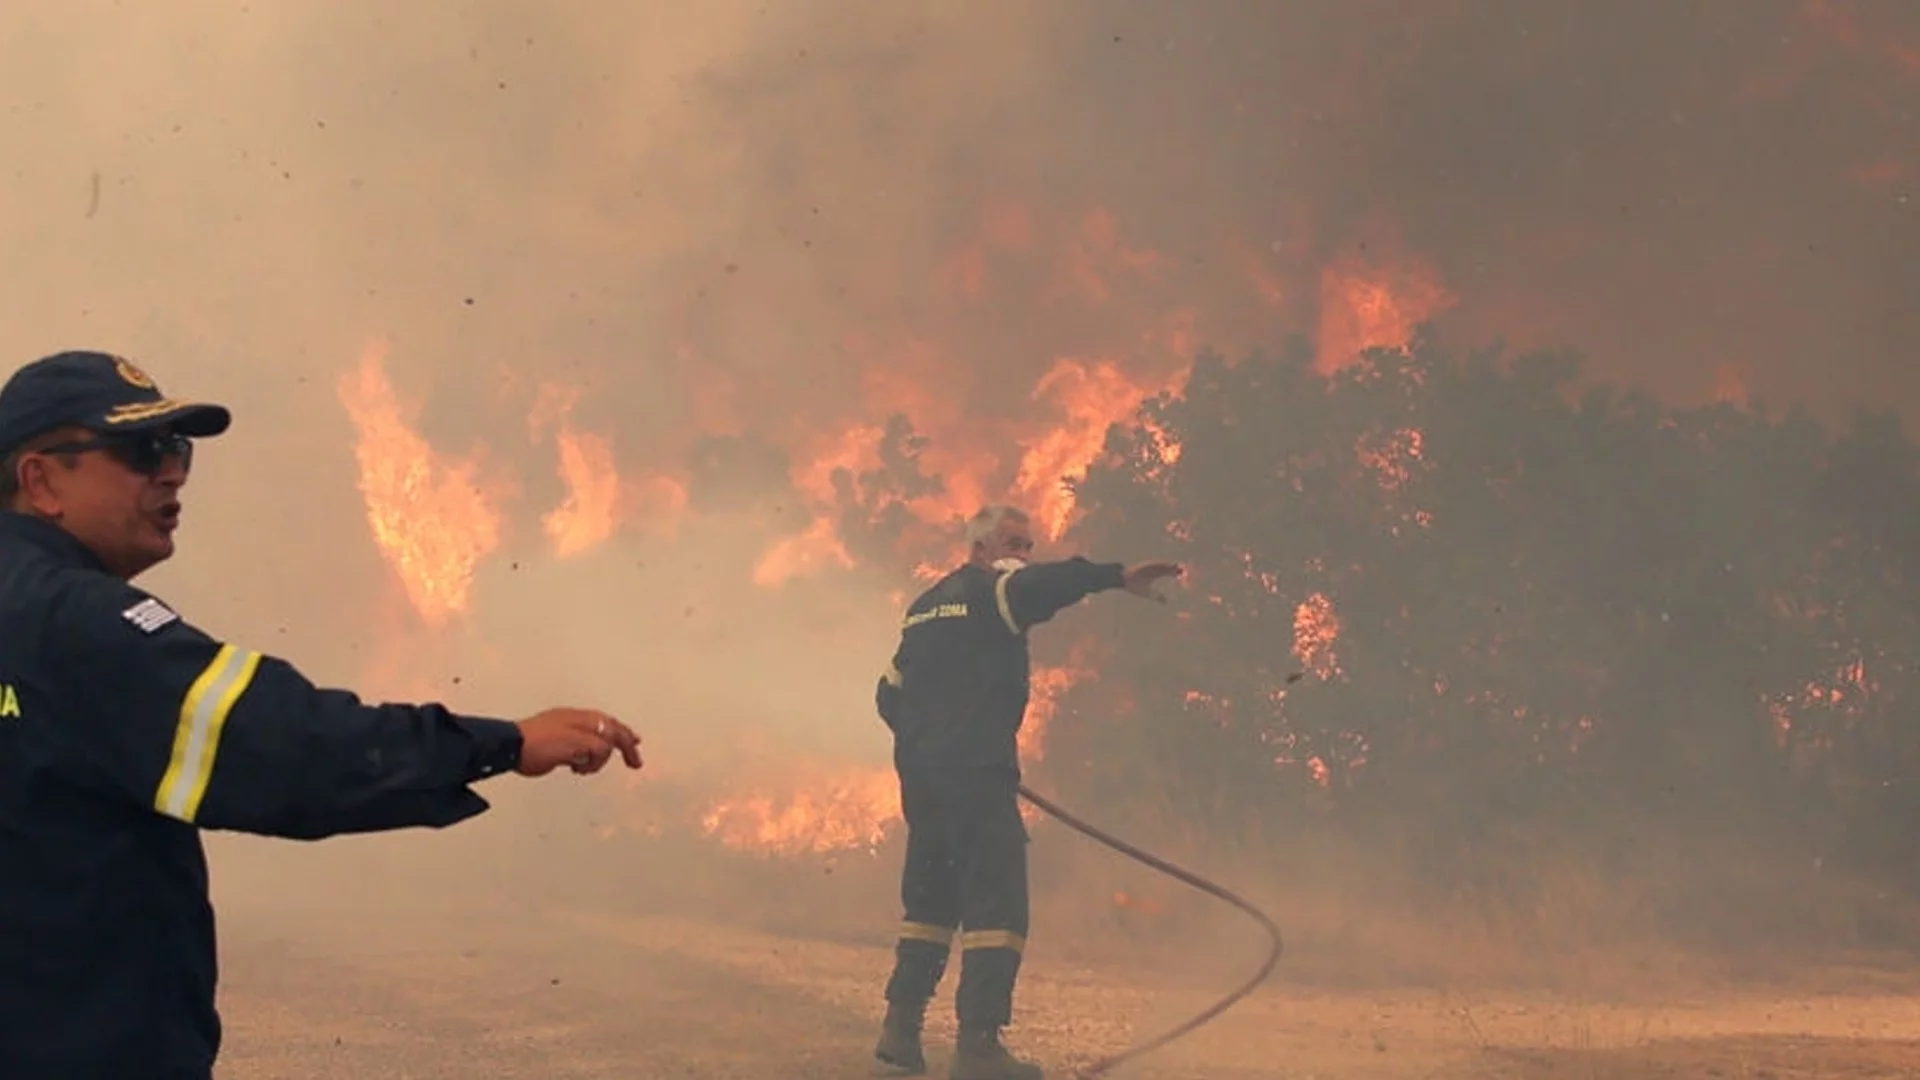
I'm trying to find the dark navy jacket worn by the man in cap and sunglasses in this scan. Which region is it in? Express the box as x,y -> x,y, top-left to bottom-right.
0,511 -> 520,1080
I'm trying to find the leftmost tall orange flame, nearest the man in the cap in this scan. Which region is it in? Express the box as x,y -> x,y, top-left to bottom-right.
338,336 -> 501,626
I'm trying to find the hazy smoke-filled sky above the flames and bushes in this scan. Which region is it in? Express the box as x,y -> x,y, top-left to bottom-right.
0,0 -> 1920,669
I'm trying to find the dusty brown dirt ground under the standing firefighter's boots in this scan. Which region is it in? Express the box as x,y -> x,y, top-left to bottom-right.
210,895 -> 1920,1080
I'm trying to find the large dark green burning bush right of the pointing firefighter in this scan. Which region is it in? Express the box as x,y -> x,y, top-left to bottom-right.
1050,332 -> 1920,887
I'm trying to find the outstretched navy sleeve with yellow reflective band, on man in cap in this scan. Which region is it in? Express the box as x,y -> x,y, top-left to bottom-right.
46,582 -> 520,840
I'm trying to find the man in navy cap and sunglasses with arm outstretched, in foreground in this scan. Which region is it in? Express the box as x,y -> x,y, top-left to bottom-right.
0,352 -> 639,1080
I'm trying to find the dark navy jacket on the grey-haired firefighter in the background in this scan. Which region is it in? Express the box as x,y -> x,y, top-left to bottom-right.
876,557 -> 1125,776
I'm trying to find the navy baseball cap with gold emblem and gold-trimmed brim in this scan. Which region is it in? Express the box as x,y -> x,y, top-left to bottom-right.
0,352 -> 232,454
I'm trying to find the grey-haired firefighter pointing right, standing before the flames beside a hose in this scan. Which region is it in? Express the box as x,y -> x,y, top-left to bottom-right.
874,507 -> 1181,1080
